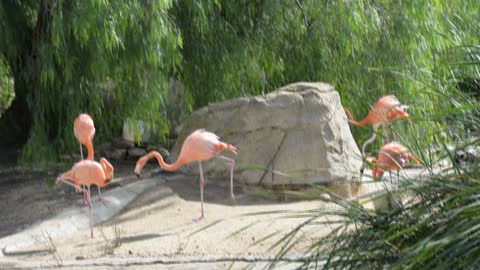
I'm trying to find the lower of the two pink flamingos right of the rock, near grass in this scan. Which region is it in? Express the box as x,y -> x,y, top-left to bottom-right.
367,142 -> 420,180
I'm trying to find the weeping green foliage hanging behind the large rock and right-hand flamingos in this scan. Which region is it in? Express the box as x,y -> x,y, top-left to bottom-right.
174,0 -> 479,152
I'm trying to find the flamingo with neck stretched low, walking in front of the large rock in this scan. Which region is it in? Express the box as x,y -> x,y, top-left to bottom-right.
135,129 -> 237,220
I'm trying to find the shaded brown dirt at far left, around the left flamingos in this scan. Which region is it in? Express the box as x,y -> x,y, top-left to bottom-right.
0,157 -> 136,239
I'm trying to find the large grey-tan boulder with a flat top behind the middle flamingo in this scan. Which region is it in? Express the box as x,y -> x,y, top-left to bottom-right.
172,82 -> 361,189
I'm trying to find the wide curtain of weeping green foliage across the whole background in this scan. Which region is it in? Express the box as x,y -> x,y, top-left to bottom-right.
0,0 -> 480,164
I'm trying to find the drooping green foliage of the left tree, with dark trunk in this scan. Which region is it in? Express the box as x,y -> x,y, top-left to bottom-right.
0,0 -> 181,165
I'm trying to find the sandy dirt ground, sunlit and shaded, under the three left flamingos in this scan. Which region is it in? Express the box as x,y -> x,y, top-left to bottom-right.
0,148 -> 330,264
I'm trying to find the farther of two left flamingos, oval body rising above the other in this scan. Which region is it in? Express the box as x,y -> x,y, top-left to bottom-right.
73,113 -> 106,204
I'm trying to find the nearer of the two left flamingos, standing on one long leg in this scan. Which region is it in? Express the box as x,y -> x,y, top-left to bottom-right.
57,158 -> 114,238
